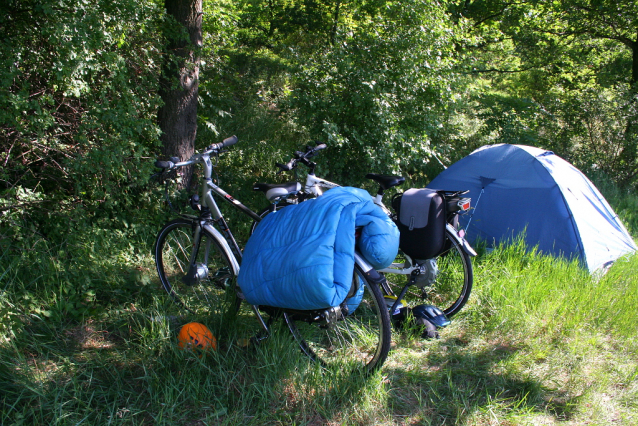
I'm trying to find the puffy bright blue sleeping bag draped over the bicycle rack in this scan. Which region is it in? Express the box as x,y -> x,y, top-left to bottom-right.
238,187 -> 399,310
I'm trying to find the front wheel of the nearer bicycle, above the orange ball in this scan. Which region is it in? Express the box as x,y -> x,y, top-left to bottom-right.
154,219 -> 241,316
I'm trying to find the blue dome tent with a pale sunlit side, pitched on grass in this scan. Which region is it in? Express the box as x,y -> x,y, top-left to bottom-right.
428,144 -> 638,272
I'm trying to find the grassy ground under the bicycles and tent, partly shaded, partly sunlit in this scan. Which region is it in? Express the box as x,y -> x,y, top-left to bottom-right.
0,182 -> 638,425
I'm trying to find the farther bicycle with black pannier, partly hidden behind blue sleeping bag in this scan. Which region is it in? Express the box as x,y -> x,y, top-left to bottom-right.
251,143 -> 476,318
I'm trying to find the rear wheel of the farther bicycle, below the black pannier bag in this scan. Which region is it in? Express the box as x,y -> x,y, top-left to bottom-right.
386,228 -> 474,318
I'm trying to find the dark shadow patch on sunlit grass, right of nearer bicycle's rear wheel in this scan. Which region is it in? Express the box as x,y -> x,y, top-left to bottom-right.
386,338 -> 578,425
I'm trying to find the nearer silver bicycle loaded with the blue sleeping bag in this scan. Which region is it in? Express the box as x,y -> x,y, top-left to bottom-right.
153,136 -> 391,371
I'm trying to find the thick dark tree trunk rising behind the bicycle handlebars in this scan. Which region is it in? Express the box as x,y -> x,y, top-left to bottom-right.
158,0 -> 202,187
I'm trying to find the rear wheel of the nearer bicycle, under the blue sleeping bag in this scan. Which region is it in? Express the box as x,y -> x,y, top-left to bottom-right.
284,265 -> 391,372
